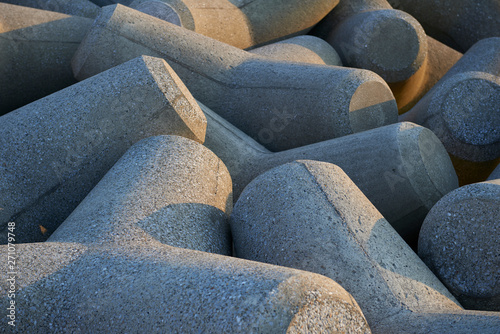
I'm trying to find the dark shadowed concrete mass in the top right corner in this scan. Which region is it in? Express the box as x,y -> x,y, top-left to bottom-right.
387,0 -> 500,52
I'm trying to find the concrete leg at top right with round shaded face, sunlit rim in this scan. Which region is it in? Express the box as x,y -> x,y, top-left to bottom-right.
313,0 -> 427,82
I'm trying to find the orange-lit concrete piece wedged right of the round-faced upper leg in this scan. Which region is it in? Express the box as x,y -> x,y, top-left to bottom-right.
389,36 -> 462,114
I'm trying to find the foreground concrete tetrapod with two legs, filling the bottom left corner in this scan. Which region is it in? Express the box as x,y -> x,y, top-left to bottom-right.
1,136 -> 370,333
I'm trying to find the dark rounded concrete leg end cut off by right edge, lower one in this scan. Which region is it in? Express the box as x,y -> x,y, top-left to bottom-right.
418,179 -> 500,311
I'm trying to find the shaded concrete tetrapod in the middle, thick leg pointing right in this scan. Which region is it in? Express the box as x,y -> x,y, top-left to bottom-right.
199,103 -> 458,246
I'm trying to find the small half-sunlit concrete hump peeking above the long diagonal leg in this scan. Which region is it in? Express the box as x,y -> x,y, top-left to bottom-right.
250,35 -> 342,66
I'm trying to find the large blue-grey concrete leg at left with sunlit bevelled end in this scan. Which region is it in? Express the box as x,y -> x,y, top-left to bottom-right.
0,57 -> 206,243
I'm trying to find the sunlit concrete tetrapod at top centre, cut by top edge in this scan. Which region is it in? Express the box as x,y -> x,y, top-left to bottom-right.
130,0 -> 339,49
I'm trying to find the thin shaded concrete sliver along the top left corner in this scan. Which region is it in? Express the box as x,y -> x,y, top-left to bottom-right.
2,0 -> 100,19
